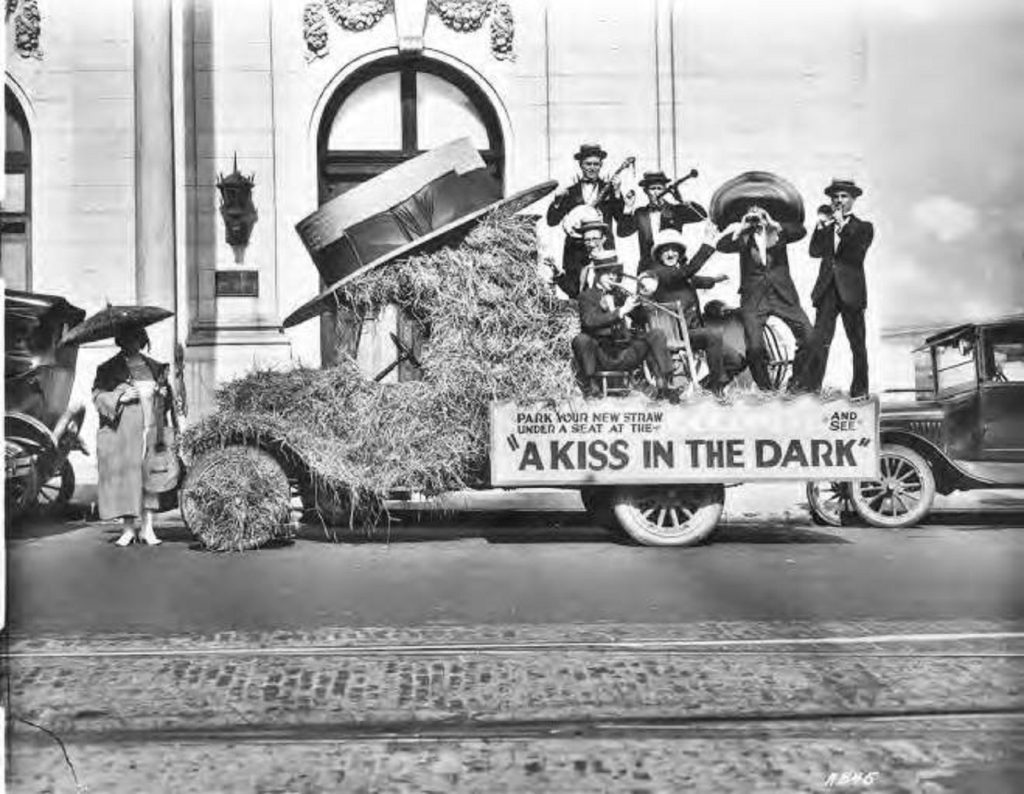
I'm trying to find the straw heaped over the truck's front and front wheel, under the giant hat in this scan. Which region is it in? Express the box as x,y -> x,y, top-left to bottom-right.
182,210 -> 579,548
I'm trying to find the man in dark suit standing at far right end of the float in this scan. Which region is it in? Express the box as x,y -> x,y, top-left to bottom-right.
809,179 -> 874,398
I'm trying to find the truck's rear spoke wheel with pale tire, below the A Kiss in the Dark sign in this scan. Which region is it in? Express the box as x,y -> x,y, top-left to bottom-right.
612,485 -> 725,546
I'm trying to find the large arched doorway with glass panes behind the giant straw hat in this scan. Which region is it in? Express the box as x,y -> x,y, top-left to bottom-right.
316,56 -> 505,370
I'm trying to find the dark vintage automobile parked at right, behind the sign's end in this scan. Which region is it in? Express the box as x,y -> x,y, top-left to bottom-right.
807,315 -> 1024,528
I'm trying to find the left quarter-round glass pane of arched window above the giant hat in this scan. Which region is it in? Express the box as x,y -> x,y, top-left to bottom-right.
327,72 -> 401,151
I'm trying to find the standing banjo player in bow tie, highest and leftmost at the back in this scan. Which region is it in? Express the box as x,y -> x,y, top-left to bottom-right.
547,143 -> 624,298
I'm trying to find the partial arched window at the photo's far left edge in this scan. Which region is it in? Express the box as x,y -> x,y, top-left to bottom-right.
0,86 -> 32,290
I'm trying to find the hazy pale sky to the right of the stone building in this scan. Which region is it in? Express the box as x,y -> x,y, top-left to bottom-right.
865,0 -> 1024,328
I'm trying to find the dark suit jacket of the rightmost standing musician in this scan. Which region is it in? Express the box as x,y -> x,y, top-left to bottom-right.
810,215 -> 874,308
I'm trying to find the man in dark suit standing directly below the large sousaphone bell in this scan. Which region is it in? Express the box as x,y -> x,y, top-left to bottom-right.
718,204 -> 814,391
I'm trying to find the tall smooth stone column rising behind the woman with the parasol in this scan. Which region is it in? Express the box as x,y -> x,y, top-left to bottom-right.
134,0 -> 178,362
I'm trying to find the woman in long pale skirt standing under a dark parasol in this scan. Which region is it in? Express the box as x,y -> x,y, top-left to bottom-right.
67,306 -> 173,546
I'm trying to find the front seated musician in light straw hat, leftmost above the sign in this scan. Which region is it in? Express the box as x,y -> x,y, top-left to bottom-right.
572,251 -> 676,399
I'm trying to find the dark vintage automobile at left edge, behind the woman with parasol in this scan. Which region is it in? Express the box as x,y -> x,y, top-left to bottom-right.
4,290 -> 85,521
